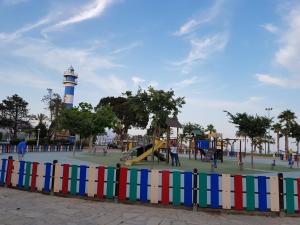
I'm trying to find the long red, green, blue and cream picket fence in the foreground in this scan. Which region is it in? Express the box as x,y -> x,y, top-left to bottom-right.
0,159 -> 300,214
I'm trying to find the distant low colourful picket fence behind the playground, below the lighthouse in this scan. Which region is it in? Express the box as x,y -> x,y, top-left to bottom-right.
0,144 -> 81,154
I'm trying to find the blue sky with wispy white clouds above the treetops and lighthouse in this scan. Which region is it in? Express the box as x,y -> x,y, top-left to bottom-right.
0,0 -> 300,140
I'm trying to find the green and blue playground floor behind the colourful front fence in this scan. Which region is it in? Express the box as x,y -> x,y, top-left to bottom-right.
1,149 -> 300,177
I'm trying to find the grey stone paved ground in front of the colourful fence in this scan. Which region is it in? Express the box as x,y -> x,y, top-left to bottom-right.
0,188 -> 300,225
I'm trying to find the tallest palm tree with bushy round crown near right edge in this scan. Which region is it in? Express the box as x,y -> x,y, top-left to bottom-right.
278,109 -> 297,154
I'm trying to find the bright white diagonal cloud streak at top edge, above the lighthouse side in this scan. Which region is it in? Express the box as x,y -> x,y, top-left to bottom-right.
45,0 -> 114,32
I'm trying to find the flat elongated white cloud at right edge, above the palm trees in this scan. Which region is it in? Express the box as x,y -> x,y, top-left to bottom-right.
256,73 -> 300,88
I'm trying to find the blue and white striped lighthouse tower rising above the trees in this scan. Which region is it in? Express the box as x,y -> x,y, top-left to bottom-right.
63,66 -> 78,109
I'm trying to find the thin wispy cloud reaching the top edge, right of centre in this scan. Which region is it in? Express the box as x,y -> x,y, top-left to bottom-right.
174,0 -> 224,36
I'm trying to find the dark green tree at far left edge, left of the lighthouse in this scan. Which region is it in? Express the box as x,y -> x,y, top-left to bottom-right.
0,94 -> 33,139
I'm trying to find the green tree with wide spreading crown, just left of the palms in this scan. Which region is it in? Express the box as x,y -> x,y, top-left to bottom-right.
225,111 -> 272,168
